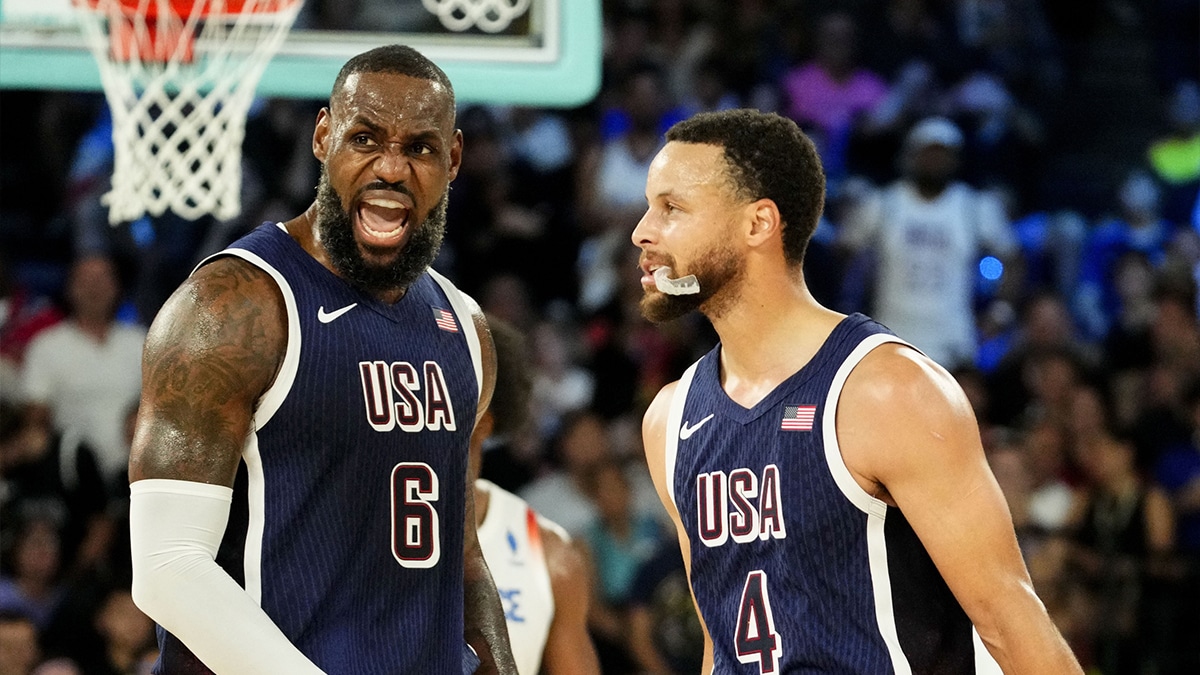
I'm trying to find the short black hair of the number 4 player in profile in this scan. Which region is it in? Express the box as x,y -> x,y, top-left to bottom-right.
667,108 -> 824,267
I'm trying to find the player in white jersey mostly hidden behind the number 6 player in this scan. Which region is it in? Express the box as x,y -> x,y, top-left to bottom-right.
468,316 -> 600,675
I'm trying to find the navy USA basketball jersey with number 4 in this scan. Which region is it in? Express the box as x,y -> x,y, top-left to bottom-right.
666,315 -> 1000,674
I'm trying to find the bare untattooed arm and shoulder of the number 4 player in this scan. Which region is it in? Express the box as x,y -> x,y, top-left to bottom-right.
838,345 -> 1081,674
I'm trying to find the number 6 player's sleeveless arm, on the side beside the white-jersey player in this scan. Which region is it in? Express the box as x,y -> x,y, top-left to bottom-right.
462,306 -> 517,675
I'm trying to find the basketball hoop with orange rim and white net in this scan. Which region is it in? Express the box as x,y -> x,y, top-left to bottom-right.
71,0 -> 302,225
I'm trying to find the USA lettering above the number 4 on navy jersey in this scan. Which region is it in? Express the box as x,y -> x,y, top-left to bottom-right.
696,464 -> 787,548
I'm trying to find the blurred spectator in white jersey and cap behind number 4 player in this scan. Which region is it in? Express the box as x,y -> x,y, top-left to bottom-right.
842,118 -> 1016,368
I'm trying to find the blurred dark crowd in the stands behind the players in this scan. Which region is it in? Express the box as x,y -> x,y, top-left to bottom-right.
0,0 -> 1200,675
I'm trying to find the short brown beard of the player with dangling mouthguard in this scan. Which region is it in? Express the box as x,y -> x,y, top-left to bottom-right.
640,241 -> 745,323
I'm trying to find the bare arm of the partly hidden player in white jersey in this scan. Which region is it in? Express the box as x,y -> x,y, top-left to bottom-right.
540,526 -> 600,675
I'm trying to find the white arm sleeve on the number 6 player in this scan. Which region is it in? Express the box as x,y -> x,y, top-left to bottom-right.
130,478 -> 322,675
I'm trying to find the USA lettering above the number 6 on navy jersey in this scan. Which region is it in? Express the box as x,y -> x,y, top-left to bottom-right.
359,360 -> 458,431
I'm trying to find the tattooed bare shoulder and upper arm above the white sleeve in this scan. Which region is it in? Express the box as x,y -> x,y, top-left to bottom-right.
130,257 -> 287,483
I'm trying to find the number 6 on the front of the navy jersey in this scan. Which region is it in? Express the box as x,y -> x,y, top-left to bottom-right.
391,461 -> 442,569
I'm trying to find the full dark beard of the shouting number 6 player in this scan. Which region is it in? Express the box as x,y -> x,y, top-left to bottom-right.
317,166 -> 450,293
